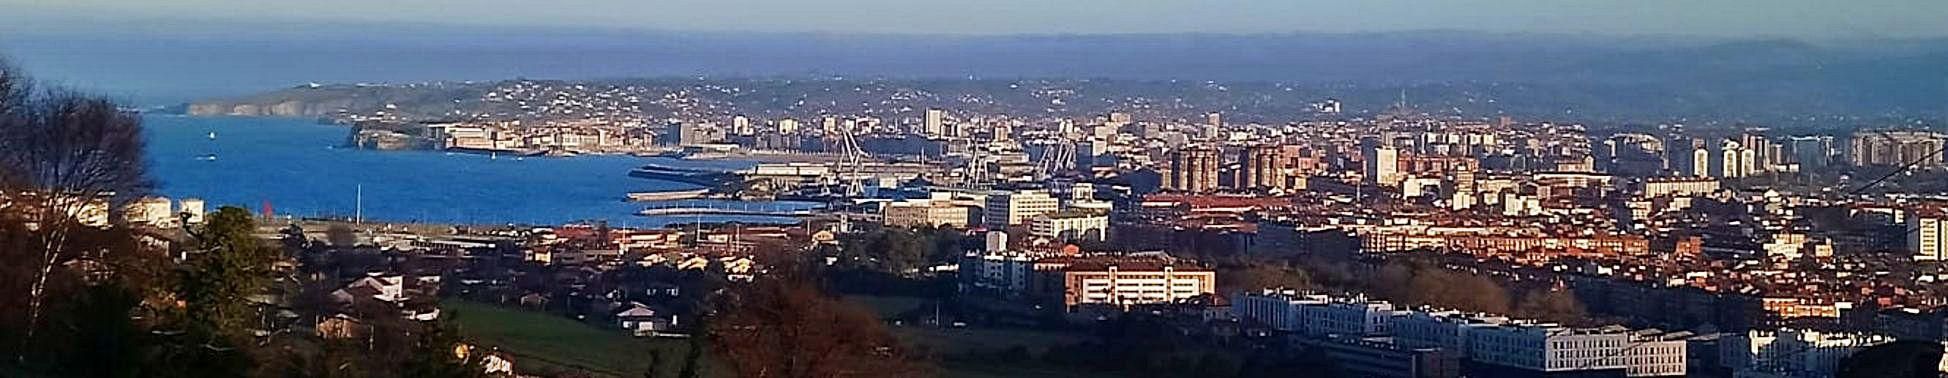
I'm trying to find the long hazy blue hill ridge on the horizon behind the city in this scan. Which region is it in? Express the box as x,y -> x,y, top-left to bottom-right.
163,33 -> 1948,125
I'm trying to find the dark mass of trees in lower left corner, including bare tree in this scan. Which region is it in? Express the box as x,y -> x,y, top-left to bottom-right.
0,64 -> 479,376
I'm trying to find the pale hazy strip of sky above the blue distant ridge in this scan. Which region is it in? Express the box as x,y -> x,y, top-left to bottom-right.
11,0 -> 1948,39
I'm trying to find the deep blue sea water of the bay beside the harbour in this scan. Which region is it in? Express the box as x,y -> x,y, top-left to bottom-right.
144,115 -> 808,226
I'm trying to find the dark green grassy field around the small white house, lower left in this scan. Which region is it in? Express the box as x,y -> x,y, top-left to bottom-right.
440,300 -> 688,376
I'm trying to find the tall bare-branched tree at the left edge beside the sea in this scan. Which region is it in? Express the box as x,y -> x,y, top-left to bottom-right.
0,59 -> 150,357
